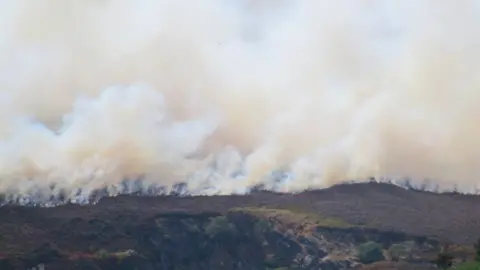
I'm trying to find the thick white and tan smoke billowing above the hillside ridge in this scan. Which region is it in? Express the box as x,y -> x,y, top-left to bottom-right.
0,0 -> 480,202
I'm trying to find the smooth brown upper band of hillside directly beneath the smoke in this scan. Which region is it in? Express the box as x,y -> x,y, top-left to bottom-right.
0,183 -> 480,247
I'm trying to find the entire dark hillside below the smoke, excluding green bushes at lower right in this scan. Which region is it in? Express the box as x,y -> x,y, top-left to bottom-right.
0,183 -> 480,270
